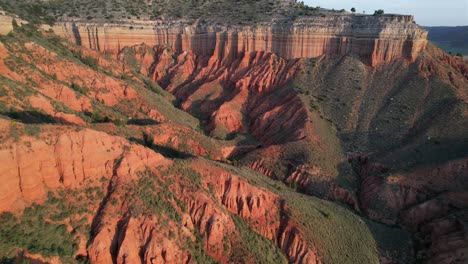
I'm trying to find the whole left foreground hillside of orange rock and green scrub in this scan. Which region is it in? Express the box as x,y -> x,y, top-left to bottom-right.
0,20 -> 411,263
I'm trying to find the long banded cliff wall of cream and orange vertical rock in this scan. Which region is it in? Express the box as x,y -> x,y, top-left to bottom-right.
54,14 -> 427,65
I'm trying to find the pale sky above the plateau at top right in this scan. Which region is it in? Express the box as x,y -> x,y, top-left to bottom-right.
303,0 -> 468,26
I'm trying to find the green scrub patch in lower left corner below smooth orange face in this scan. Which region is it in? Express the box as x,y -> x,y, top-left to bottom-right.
0,181 -> 105,263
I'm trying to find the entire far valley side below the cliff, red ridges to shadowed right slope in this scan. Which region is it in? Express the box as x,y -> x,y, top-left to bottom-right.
104,18 -> 468,263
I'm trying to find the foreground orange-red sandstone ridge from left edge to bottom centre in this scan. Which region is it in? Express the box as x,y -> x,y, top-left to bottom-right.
0,121 -> 322,263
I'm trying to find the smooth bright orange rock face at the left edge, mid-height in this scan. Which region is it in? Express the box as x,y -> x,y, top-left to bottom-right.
0,121 -> 167,211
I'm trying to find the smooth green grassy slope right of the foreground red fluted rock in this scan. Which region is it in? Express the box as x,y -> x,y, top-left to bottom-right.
217,163 -> 412,264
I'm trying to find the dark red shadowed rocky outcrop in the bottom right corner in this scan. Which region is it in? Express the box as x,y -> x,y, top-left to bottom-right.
355,158 -> 468,263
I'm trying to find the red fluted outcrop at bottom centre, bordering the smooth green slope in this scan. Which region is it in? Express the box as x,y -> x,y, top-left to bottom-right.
194,162 -> 322,263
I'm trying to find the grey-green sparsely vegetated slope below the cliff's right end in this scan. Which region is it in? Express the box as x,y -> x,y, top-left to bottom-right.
296,54 -> 467,169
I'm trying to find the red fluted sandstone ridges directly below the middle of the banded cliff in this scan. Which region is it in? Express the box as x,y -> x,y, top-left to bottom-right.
121,42 -> 308,144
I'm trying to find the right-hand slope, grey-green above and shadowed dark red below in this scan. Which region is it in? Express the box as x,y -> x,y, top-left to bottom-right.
297,45 -> 468,263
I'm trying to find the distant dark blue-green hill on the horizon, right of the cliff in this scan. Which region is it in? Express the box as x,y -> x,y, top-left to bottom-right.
424,26 -> 468,56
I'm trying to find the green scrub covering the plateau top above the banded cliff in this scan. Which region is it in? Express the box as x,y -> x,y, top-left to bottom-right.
0,0 -> 321,24
